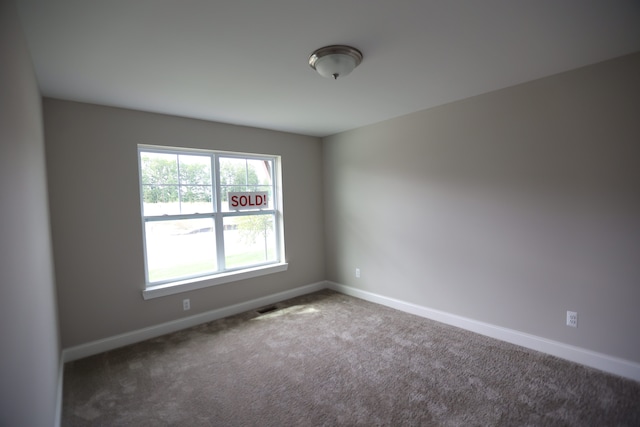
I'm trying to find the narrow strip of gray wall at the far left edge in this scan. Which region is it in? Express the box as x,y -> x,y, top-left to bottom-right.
0,0 -> 60,427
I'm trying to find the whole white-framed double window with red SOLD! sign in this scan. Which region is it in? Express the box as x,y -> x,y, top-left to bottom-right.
138,146 -> 284,294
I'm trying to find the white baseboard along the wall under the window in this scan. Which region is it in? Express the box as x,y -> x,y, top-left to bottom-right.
62,282 -> 327,363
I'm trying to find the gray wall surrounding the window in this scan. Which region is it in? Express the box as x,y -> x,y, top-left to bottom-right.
44,99 -> 324,348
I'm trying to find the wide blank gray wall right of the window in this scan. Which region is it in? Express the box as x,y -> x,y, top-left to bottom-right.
323,53 -> 640,362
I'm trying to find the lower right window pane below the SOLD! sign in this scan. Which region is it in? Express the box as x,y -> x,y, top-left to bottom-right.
224,214 -> 277,268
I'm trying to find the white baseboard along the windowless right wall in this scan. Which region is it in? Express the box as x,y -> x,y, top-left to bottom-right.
327,282 -> 640,381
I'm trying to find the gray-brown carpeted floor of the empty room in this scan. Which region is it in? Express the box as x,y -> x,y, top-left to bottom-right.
62,290 -> 640,426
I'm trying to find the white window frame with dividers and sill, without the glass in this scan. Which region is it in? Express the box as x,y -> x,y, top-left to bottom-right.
137,144 -> 288,300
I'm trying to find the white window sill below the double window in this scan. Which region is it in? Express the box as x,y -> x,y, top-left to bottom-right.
142,262 -> 289,300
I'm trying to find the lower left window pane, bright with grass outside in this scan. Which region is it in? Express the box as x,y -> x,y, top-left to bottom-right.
145,218 -> 218,282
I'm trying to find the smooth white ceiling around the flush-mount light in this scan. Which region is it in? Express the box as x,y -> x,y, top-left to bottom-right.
17,0 -> 640,136
